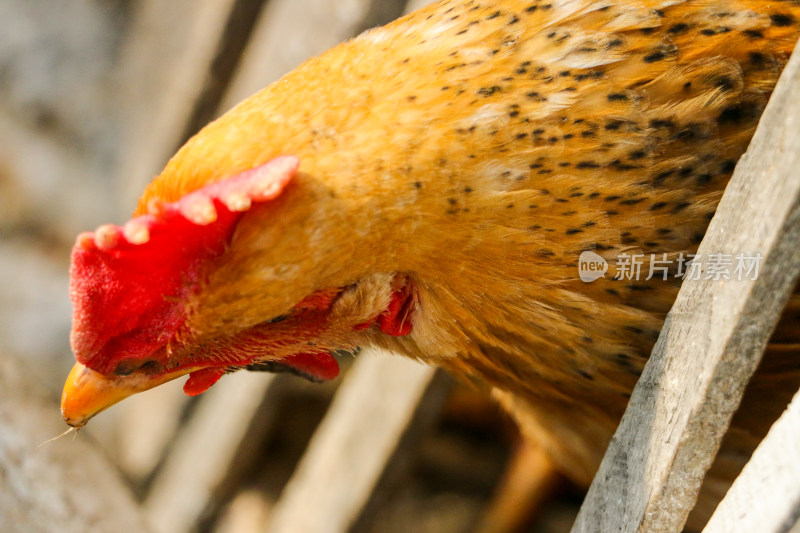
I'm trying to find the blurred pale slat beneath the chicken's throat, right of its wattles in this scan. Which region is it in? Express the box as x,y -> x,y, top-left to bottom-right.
266,352 -> 446,533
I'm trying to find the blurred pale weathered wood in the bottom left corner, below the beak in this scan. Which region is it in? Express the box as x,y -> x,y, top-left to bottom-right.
0,353 -> 149,533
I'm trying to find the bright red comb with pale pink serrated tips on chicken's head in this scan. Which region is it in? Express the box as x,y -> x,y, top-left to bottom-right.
70,156 -> 298,374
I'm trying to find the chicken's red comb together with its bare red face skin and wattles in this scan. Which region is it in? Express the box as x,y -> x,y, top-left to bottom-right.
70,156 -> 415,395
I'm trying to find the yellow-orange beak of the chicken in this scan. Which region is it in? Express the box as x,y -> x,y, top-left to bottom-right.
61,363 -> 194,428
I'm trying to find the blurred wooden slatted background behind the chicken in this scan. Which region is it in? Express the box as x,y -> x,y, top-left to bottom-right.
0,0 -> 582,533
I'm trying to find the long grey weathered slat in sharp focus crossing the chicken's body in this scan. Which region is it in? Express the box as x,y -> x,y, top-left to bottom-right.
573,48 -> 800,532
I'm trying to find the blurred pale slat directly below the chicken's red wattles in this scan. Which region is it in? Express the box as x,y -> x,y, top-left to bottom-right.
144,372 -> 280,533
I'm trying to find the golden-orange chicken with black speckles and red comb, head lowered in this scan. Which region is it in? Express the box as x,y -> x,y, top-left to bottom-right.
62,0 -> 800,524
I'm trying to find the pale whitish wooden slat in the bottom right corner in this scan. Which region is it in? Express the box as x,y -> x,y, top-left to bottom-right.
703,384 -> 800,533
